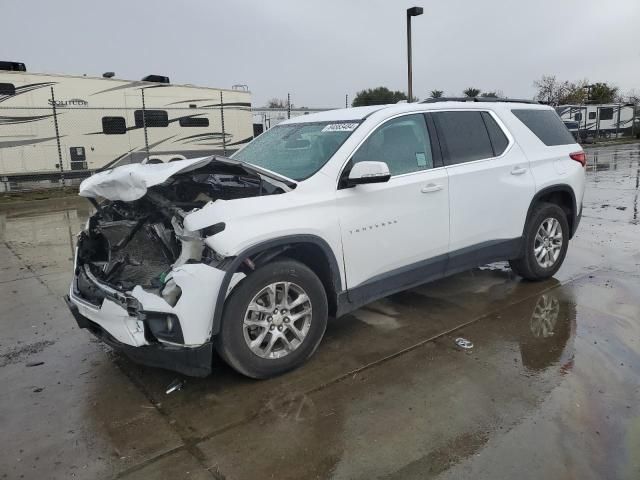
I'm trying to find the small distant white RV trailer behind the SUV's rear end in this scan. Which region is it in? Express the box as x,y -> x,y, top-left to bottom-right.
556,103 -> 634,138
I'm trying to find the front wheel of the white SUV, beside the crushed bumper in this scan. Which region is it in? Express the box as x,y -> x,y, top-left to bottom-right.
215,259 -> 328,379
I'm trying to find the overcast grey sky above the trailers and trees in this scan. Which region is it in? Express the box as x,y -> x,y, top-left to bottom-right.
5,0 -> 640,107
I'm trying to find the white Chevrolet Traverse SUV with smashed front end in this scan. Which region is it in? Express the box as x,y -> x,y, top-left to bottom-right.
68,101 -> 586,378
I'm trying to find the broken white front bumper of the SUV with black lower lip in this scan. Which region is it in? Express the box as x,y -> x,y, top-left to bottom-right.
65,240 -> 226,376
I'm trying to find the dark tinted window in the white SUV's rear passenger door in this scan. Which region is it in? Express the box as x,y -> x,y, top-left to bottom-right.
433,112 -> 496,165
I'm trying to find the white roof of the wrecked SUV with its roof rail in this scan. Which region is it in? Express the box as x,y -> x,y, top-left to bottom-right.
279,101 -> 552,125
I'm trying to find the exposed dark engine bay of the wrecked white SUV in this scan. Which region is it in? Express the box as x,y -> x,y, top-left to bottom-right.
76,157 -> 286,305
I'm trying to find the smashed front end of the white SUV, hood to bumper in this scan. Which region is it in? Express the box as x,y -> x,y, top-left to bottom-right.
67,158 -> 287,376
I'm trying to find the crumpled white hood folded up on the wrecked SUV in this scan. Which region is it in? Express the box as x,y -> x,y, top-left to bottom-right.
79,157 -> 214,202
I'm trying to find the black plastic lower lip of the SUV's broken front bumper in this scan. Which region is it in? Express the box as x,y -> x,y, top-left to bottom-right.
64,296 -> 213,377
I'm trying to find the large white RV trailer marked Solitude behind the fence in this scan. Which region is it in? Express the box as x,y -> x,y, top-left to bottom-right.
0,71 -> 253,178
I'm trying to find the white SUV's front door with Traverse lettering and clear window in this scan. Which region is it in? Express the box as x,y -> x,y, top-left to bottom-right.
336,113 -> 449,304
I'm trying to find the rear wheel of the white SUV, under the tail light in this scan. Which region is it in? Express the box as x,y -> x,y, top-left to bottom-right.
509,203 -> 569,281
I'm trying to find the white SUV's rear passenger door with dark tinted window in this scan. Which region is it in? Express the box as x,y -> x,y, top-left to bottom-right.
433,110 -> 535,273
